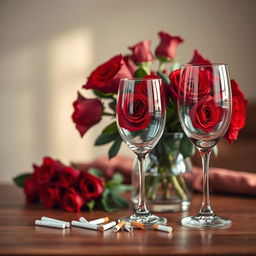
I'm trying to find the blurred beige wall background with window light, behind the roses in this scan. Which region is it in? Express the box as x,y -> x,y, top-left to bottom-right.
0,0 -> 256,182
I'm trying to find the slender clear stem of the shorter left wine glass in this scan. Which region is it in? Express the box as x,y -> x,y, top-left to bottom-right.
136,155 -> 149,215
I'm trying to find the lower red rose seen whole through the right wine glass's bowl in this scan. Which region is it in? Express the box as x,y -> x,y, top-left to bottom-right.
189,96 -> 223,132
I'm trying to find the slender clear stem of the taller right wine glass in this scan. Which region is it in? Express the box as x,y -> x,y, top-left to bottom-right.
199,149 -> 213,215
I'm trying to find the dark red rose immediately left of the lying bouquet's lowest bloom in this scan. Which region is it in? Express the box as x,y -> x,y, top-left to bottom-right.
40,186 -> 60,208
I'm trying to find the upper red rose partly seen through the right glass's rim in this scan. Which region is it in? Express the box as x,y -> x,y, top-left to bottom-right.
169,69 -> 213,102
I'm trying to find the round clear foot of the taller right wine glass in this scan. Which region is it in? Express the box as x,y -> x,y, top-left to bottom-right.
181,215 -> 232,228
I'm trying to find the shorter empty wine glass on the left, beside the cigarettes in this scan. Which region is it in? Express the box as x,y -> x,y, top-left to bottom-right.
117,78 -> 166,225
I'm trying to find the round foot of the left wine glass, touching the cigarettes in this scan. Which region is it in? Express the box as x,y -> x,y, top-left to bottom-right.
119,213 -> 167,226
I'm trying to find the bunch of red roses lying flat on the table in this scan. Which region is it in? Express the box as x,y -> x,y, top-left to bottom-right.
14,157 -> 130,212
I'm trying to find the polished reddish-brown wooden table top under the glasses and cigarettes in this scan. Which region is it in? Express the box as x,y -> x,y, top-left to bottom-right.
0,185 -> 256,256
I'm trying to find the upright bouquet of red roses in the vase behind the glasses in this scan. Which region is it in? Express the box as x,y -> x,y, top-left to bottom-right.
72,31 -> 247,158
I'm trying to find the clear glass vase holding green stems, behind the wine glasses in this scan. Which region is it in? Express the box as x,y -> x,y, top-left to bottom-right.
132,132 -> 193,212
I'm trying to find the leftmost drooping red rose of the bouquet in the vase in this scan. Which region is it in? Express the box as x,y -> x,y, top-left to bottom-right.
72,92 -> 103,137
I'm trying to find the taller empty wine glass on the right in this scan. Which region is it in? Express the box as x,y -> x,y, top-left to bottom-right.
178,64 -> 232,227
